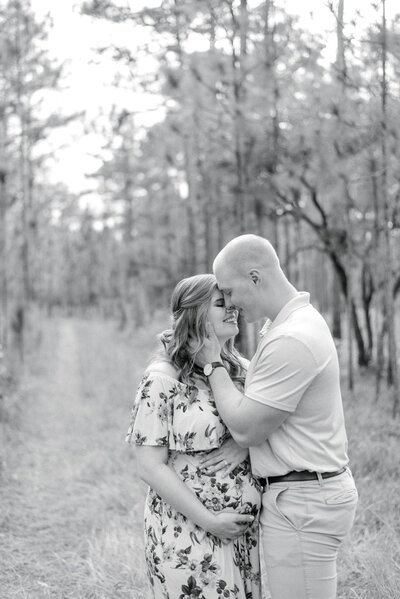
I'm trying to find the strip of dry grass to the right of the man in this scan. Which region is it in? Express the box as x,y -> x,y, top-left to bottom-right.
339,373 -> 400,599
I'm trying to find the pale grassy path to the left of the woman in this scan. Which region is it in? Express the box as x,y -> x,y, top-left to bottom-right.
0,320 -> 156,599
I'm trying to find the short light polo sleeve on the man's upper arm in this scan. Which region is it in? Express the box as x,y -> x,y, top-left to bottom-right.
245,336 -> 318,412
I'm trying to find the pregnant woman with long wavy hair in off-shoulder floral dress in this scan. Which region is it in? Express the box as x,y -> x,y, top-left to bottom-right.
127,274 -> 260,599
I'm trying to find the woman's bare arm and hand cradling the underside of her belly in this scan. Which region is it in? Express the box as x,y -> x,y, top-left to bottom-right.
136,445 -> 254,539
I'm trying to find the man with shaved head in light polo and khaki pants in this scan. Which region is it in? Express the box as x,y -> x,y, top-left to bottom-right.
199,235 -> 358,599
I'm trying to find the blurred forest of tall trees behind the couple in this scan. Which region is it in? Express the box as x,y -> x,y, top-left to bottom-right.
0,0 -> 400,413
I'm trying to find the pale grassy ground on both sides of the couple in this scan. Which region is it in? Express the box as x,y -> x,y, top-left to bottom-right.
0,319 -> 400,599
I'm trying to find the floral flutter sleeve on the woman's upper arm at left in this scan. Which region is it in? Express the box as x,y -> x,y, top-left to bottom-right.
125,373 -> 172,447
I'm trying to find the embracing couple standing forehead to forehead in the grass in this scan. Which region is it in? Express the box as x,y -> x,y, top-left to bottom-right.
127,235 -> 358,599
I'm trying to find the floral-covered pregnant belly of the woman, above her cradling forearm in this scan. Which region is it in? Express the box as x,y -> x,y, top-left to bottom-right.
171,453 -> 261,516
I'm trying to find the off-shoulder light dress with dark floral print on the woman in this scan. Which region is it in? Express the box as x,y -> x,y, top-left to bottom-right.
126,373 -> 261,599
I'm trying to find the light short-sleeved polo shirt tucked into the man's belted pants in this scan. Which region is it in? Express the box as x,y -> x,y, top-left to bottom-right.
245,292 -> 348,477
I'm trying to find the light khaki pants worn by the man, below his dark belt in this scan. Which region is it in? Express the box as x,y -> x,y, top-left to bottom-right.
260,469 -> 358,599
